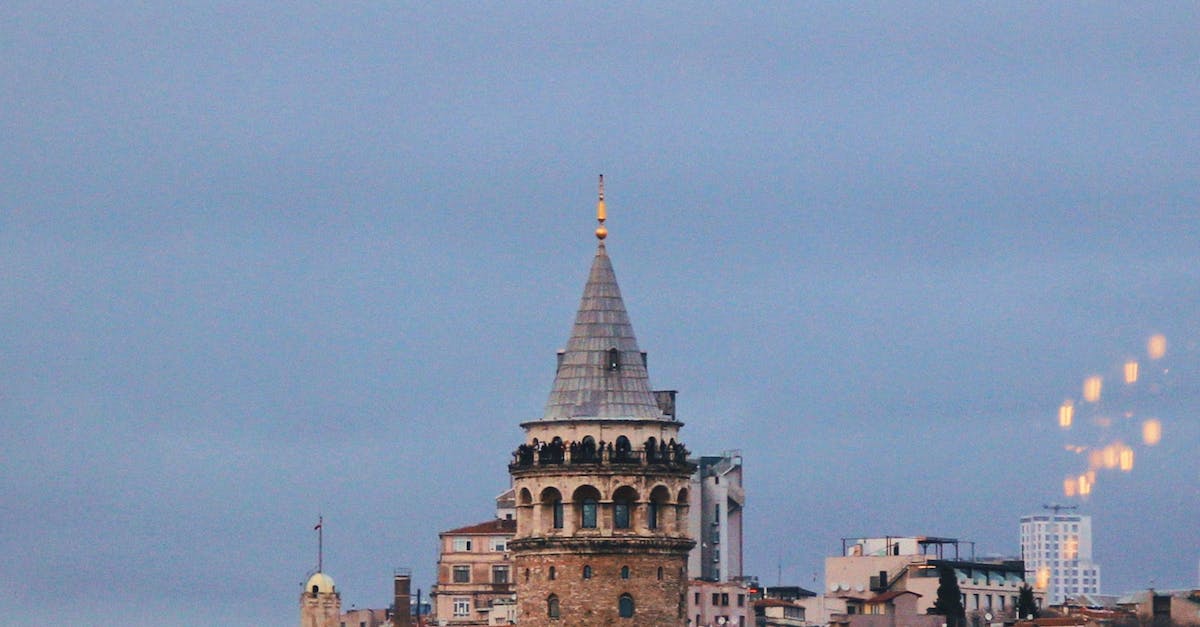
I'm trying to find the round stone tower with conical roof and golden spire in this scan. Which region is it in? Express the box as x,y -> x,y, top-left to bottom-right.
509,178 -> 695,627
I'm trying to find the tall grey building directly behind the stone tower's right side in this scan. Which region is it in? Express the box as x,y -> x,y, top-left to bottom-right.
688,452 -> 745,581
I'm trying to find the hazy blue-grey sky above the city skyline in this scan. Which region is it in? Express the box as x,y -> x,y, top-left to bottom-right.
0,1 -> 1200,626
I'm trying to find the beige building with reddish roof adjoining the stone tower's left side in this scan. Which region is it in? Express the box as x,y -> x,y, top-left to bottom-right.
430,518 -> 516,625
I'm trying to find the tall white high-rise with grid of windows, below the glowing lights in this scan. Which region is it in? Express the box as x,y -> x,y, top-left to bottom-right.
1021,506 -> 1100,605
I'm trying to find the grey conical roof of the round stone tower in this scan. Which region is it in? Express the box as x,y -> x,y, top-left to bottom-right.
542,243 -> 670,420
